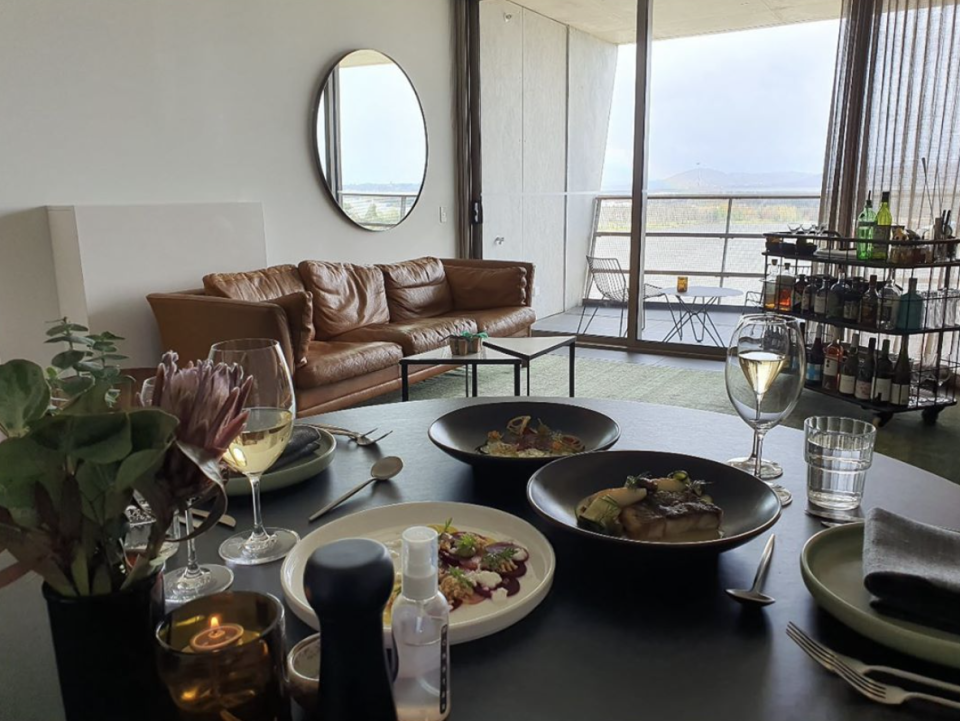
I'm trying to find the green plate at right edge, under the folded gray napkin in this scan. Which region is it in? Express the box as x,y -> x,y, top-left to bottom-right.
800,523 -> 960,668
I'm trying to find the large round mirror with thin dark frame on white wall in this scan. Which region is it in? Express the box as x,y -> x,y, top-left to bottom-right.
314,50 -> 427,230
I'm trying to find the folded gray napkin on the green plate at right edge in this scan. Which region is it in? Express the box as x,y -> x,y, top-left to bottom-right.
863,508 -> 960,633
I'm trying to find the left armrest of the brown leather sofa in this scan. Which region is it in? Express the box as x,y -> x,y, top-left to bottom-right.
147,291 -> 295,373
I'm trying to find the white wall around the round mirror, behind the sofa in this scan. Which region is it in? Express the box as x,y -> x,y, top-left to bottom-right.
0,0 -> 456,360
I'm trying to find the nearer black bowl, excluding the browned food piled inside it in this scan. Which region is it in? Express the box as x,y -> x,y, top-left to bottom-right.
527,451 -> 780,553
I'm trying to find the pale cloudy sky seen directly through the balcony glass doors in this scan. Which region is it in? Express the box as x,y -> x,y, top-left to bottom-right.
602,20 -> 838,191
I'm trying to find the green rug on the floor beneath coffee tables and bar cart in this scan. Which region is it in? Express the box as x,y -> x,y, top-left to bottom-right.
370,355 -> 960,483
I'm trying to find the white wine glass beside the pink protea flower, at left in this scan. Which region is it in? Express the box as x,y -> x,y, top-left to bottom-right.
210,338 -> 300,566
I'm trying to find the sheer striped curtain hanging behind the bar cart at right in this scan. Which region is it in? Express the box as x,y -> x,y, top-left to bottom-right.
820,0 -> 960,235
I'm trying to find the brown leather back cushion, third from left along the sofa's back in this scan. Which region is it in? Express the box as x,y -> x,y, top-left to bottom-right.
378,258 -> 453,323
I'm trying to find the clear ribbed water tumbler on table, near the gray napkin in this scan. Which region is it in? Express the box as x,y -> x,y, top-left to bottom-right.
803,416 -> 877,511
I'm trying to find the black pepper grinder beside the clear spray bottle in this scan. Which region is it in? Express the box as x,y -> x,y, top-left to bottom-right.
303,538 -> 397,721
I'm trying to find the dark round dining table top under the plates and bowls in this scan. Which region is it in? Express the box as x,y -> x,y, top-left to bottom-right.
0,398 -> 960,721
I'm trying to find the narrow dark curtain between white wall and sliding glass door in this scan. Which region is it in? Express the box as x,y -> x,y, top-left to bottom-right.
453,0 -> 483,258
